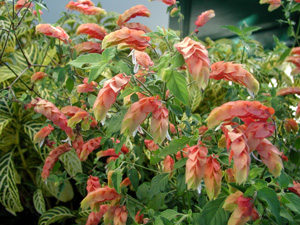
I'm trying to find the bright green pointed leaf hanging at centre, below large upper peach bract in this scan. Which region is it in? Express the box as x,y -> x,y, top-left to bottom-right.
166,70 -> 189,105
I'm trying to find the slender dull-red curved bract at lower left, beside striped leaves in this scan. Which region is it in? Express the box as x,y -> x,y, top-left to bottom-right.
41,143 -> 71,180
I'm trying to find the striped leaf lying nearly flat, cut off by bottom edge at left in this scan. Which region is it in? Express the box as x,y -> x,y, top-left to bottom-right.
38,206 -> 74,225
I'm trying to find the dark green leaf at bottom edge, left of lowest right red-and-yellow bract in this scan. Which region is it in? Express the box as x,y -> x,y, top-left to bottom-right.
202,197 -> 228,225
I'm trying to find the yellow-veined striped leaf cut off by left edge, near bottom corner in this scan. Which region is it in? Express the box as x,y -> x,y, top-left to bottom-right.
0,151 -> 23,216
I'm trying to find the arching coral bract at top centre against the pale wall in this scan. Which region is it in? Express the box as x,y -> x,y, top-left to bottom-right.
117,5 -> 151,27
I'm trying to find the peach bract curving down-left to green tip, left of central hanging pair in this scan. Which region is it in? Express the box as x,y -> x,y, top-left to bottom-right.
121,97 -> 161,136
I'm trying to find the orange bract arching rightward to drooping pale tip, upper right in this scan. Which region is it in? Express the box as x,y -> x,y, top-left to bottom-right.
209,61 -> 259,95
